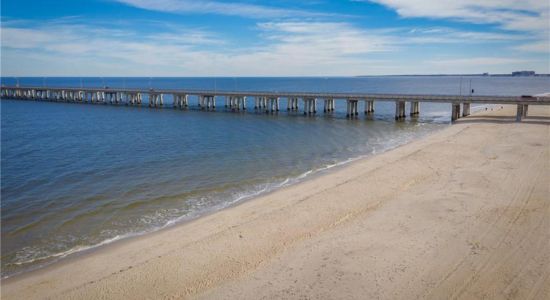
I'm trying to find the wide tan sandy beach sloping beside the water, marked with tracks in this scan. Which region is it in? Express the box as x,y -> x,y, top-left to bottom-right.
2,106 -> 550,300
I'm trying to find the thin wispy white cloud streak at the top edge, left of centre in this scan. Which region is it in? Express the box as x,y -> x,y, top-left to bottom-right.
115,0 -> 326,18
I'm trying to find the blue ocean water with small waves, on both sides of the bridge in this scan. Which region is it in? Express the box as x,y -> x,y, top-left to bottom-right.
0,76 -> 550,277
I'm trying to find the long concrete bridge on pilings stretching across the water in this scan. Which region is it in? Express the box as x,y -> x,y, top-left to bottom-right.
0,86 -> 550,122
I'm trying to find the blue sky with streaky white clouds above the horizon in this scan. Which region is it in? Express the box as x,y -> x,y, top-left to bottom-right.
0,0 -> 550,77
